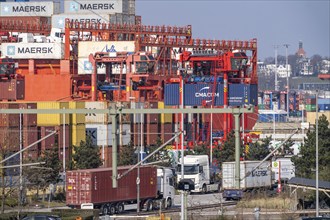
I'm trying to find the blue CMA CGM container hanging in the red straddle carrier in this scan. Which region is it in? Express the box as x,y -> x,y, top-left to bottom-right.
164,83 -> 258,106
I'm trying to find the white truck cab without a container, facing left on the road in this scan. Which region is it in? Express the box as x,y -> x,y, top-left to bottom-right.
177,155 -> 221,193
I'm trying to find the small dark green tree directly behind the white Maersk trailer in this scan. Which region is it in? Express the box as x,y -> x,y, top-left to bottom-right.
246,137 -> 271,160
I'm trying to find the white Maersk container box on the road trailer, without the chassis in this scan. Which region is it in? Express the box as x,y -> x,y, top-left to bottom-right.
222,161 -> 272,190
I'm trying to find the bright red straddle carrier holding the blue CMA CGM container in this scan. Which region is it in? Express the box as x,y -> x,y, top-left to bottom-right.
180,50 -> 252,143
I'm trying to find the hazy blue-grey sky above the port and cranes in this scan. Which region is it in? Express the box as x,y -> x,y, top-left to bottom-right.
136,0 -> 330,60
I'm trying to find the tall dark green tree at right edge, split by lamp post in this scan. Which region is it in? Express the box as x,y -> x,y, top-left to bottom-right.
292,115 -> 330,181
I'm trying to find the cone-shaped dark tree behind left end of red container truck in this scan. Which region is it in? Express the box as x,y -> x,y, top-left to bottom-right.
71,136 -> 103,169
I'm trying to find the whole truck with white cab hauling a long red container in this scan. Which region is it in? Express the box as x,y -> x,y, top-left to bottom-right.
66,166 -> 175,215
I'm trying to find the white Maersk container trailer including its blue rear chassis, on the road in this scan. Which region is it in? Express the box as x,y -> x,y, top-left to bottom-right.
222,161 -> 273,200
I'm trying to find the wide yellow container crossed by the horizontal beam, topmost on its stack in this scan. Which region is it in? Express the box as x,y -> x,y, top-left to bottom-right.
37,102 -> 70,126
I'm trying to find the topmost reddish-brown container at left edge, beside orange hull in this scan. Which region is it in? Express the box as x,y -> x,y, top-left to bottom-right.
0,79 -> 25,101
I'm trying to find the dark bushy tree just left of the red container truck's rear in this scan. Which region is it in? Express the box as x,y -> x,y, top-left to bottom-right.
23,147 -> 62,200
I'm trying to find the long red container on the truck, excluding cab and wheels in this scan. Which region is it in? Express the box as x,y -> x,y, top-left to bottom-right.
66,166 -> 158,208
